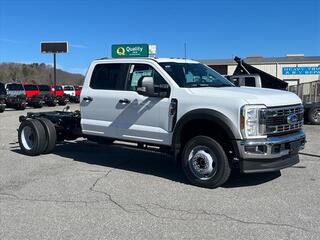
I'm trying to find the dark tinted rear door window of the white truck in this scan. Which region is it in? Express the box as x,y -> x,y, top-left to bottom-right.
90,64 -> 127,90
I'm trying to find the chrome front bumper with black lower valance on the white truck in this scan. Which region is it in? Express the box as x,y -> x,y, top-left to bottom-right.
236,130 -> 306,173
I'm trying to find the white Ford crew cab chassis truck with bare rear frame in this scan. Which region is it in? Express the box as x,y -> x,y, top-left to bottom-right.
18,58 -> 305,188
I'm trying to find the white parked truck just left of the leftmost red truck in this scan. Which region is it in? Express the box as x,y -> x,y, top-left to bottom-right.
5,83 -> 27,110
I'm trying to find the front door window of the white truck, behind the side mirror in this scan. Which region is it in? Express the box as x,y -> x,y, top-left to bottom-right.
127,64 -> 167,91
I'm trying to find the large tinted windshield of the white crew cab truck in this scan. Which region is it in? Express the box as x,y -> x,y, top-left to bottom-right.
160,62 -> 234,88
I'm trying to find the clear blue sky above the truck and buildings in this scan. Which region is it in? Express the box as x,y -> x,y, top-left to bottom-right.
0,0 -> 320,73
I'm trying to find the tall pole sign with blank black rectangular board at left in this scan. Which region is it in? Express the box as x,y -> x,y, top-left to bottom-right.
40,42 -> 68,95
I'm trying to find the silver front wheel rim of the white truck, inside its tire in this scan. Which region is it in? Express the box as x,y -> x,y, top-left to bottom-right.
188,146 -> 218,180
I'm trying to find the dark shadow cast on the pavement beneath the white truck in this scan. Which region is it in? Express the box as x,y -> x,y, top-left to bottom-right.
11,140 -> 281,188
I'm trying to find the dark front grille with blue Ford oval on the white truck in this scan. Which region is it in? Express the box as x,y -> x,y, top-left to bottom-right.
265,104 -> 304,135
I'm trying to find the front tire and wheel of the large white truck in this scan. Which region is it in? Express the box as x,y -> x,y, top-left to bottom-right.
181,136 -> 231,188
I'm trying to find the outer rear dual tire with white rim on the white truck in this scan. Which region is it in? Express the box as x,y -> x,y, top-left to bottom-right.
18,119 -> 46,156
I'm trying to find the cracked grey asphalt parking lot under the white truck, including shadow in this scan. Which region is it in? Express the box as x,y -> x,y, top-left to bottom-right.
0,105 -> 320,240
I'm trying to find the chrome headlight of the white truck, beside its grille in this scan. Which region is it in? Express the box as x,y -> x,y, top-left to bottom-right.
240,105 -> 267,138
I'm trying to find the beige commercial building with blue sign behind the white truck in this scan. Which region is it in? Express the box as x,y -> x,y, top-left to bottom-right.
200,54 -> 320,85
